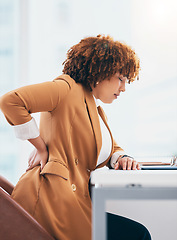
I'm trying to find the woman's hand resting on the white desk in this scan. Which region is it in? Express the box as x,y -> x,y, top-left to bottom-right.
114,156 -> 141,170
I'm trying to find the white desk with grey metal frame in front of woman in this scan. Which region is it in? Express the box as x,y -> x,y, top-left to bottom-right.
91,170 -> 177,240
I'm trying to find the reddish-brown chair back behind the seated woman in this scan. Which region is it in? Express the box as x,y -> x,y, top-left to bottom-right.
0,176 -> 54,240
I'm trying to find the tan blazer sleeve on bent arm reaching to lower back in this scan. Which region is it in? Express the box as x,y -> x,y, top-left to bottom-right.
0,79 -> 71,125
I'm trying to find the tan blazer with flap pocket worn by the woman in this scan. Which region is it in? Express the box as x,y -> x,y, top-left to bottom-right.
0,75 -> 122,240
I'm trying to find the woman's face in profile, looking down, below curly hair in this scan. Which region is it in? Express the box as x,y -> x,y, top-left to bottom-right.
92,73 -> 127,103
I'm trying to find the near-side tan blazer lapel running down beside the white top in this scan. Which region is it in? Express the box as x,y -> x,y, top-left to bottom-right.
85,87 -> 102,162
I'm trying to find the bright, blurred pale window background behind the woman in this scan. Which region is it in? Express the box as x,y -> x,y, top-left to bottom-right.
0,0 -> 177,184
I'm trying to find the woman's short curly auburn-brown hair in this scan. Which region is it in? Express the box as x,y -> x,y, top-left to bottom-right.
63,35 -> 140,90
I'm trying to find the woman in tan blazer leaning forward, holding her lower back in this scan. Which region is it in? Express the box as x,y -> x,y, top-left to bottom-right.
1,35 -> 150,240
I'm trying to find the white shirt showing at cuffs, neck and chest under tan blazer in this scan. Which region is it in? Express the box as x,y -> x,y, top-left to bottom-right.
13,96 -> 125,168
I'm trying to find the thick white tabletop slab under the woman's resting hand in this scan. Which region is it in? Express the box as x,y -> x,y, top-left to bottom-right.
91,169 -> 177,187
